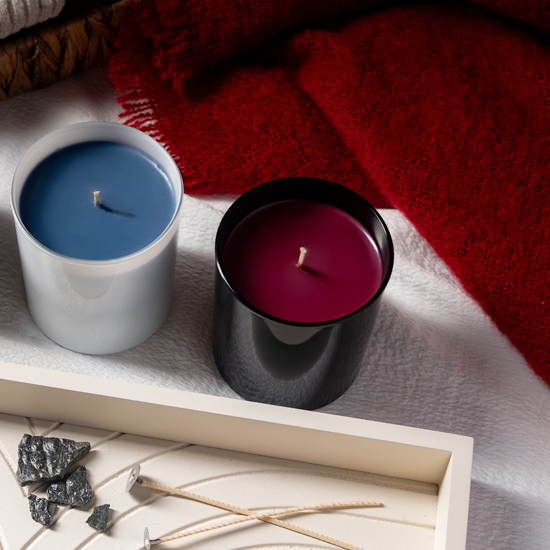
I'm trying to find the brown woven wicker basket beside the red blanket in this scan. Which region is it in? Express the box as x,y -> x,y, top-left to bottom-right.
0,0 -> 130,99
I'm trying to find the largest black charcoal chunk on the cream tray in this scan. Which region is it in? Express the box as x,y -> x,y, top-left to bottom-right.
17,434 -> 90,485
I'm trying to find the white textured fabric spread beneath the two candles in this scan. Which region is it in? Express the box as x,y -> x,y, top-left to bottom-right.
0,69 -> 550,550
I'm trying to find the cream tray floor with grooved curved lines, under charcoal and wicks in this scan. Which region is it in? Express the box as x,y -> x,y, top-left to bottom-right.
0,414 -> 437,550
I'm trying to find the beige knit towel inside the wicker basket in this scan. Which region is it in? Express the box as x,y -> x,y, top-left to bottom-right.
0,0 -> 65,39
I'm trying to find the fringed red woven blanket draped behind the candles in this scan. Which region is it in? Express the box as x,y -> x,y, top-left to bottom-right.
110,0 -> 550,383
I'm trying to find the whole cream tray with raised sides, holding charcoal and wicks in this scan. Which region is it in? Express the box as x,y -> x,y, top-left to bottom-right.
0,363 -> 473,550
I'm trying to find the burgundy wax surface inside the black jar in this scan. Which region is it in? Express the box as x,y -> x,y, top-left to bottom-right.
221,200 -> 383,323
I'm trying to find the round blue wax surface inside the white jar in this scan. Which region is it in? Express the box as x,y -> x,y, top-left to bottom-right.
19,141 -> 176,260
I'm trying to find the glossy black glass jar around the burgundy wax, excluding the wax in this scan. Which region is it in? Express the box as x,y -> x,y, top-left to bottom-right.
213,178 -> 393,409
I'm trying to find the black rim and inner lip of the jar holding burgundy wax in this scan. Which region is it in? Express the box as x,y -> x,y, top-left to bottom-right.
214,176 -> 394,327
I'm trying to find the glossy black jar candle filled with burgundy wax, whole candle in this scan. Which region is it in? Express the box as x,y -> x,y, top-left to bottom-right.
214,178 -> 393,409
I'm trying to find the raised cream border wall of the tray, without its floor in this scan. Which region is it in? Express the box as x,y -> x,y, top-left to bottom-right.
0,361 -> 473,550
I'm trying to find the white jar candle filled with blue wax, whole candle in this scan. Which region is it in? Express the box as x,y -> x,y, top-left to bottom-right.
11,122 -> 183,354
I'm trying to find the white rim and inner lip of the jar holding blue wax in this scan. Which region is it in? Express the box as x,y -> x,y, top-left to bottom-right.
10,121 -> 184,268
